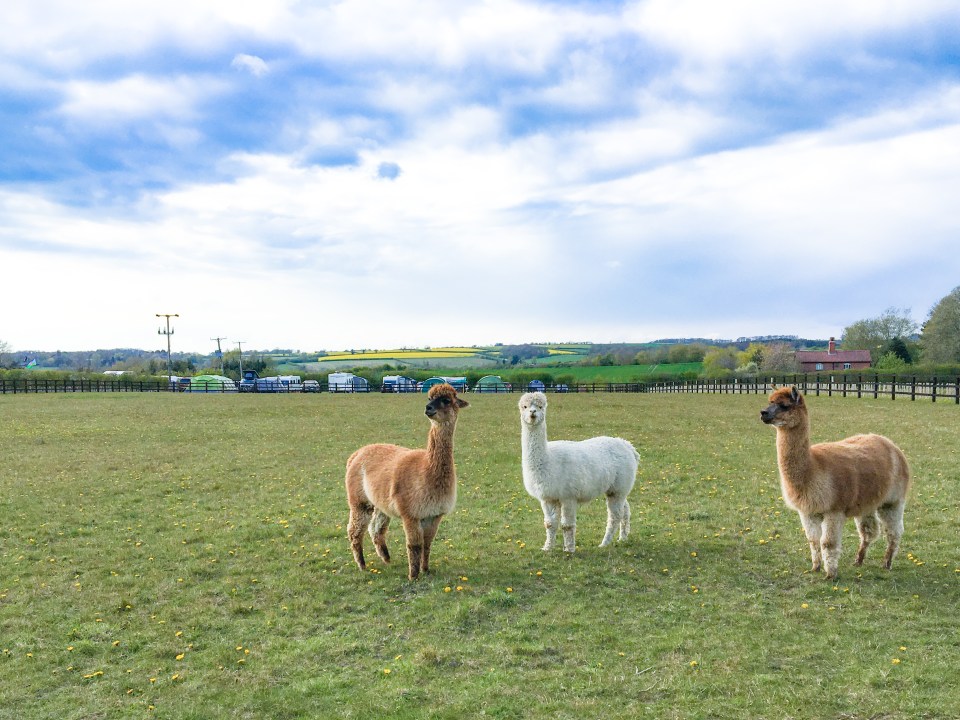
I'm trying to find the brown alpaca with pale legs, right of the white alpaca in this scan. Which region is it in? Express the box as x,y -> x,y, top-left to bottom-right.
760,388 -> 910,578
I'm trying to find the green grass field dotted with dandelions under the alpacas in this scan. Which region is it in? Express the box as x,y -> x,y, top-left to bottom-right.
0,393 -> 960,720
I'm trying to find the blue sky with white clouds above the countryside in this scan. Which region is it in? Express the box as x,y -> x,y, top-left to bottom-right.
0,0 -> 960,352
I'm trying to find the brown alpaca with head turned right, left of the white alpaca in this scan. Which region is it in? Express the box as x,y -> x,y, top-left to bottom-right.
346,384 -> 468,580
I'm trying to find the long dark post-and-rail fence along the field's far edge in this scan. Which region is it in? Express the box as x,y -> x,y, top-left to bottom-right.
0,375 -> 960,405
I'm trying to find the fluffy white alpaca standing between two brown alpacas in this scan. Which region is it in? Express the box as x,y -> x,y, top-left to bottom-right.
520,392 -> 640,553
